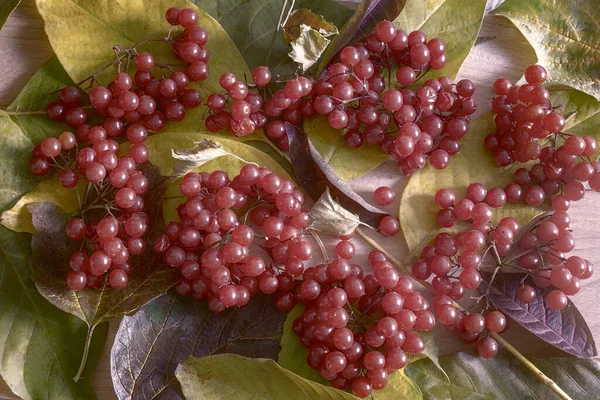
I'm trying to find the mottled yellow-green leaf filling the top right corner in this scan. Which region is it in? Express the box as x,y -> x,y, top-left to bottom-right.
493,0 -> 600,100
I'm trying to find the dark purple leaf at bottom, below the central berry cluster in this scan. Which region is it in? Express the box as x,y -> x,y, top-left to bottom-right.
110,293 -> 285,399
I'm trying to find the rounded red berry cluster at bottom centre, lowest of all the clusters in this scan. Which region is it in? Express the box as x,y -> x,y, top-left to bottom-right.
292,245 -> 428,397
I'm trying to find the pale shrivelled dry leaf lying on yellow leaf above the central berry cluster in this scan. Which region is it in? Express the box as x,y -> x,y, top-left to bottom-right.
171,139 -> 251,181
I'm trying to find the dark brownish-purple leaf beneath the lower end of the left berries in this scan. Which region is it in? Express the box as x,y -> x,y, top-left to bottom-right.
27,167 -> 179,329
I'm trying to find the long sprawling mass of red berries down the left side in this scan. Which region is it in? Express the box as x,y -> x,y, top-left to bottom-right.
29,8 -> 208,290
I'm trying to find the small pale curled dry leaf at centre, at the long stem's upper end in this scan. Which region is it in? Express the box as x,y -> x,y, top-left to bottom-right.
309,186 -> 361,236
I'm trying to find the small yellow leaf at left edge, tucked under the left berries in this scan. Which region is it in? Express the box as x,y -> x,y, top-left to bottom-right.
0,176 -> 81,234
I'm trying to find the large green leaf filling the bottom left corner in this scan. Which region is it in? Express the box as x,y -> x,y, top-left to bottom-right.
0,227 -> 108,400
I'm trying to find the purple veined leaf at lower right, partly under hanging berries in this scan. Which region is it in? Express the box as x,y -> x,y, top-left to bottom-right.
490,274 -> 598,357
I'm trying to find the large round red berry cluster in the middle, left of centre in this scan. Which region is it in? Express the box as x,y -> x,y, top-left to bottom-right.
154,164 -> 312,312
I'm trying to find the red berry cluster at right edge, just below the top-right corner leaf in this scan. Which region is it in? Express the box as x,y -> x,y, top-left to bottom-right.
485,65 -> 600,206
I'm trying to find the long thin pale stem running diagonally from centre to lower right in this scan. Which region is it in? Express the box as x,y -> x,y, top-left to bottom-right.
355,228 -> 572,400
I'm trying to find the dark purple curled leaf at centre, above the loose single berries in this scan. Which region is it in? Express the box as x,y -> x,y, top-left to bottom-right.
285,122 -> 386,226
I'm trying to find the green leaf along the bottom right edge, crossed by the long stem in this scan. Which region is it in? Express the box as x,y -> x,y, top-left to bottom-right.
405,351 -> 600,400
